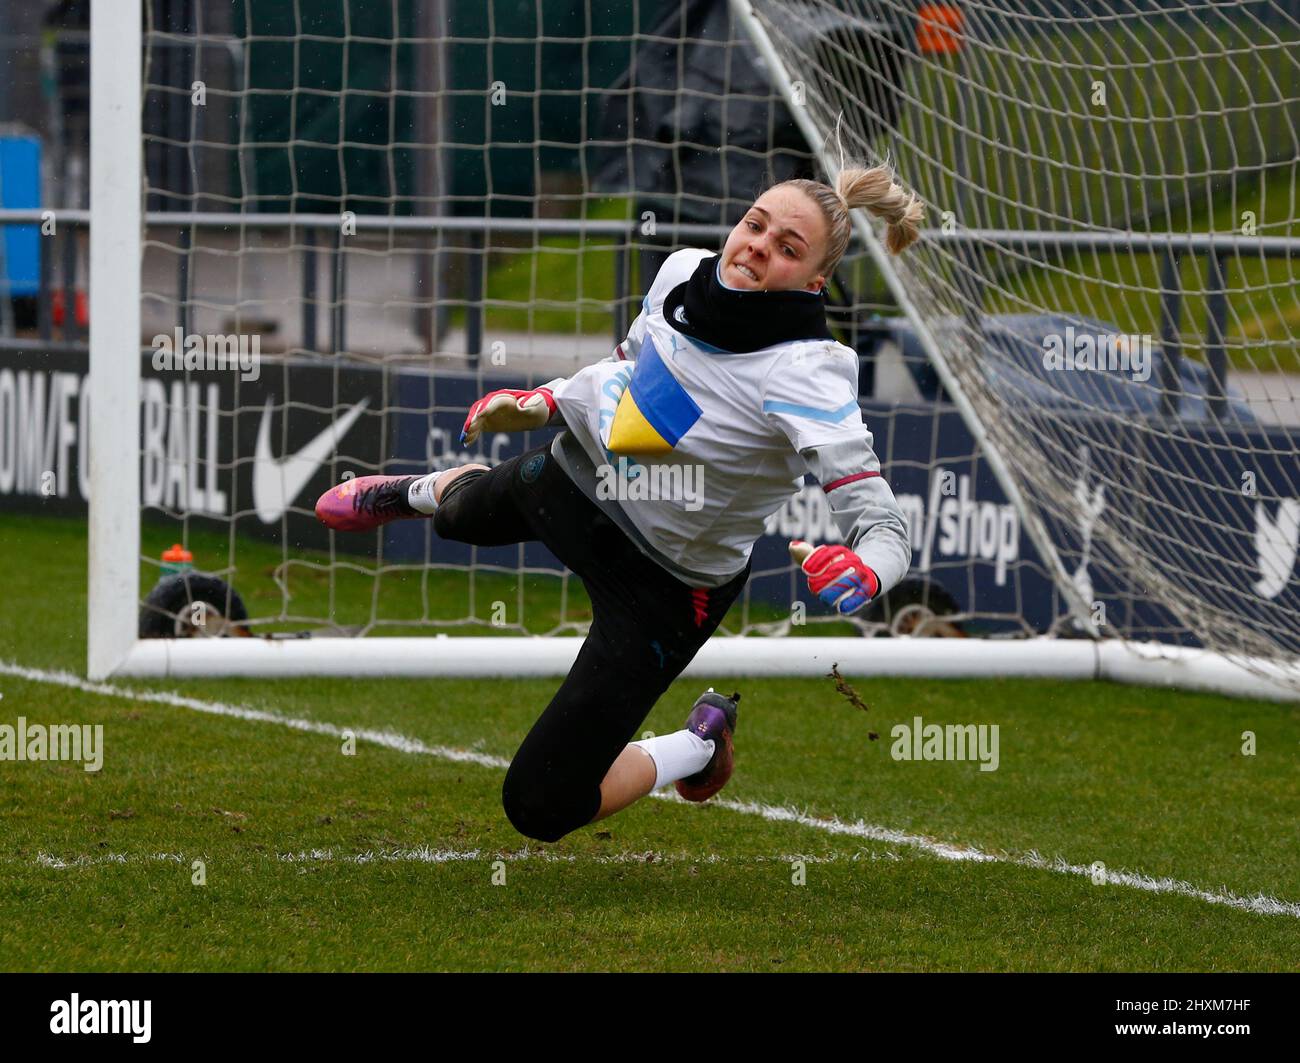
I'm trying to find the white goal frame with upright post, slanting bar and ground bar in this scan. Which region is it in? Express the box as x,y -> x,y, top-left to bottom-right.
86,0 -> 1300,700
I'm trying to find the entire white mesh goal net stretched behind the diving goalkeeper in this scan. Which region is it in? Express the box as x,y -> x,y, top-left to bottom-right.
83,0 -> 1300,684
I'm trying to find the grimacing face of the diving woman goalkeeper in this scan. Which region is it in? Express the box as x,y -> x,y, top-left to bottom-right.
722,187 -> 827,291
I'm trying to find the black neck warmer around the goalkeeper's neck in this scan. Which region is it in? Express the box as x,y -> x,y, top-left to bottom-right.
663,255 -> 835,353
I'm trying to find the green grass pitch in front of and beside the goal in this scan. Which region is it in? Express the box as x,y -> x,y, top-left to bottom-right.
0,516 -> 1300,971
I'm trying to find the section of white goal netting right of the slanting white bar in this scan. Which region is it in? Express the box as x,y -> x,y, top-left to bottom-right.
733,0 -> 1300,691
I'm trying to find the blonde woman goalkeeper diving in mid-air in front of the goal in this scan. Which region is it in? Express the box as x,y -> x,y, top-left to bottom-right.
316,168 -> 922,841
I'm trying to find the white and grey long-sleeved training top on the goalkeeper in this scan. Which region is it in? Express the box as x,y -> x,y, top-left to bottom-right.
546,248 -> 911,594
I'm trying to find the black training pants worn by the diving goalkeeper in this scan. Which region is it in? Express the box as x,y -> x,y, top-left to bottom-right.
433,443 -> 749,842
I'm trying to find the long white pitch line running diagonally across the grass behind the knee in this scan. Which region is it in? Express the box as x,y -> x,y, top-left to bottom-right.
0,660 -> 1300,919
